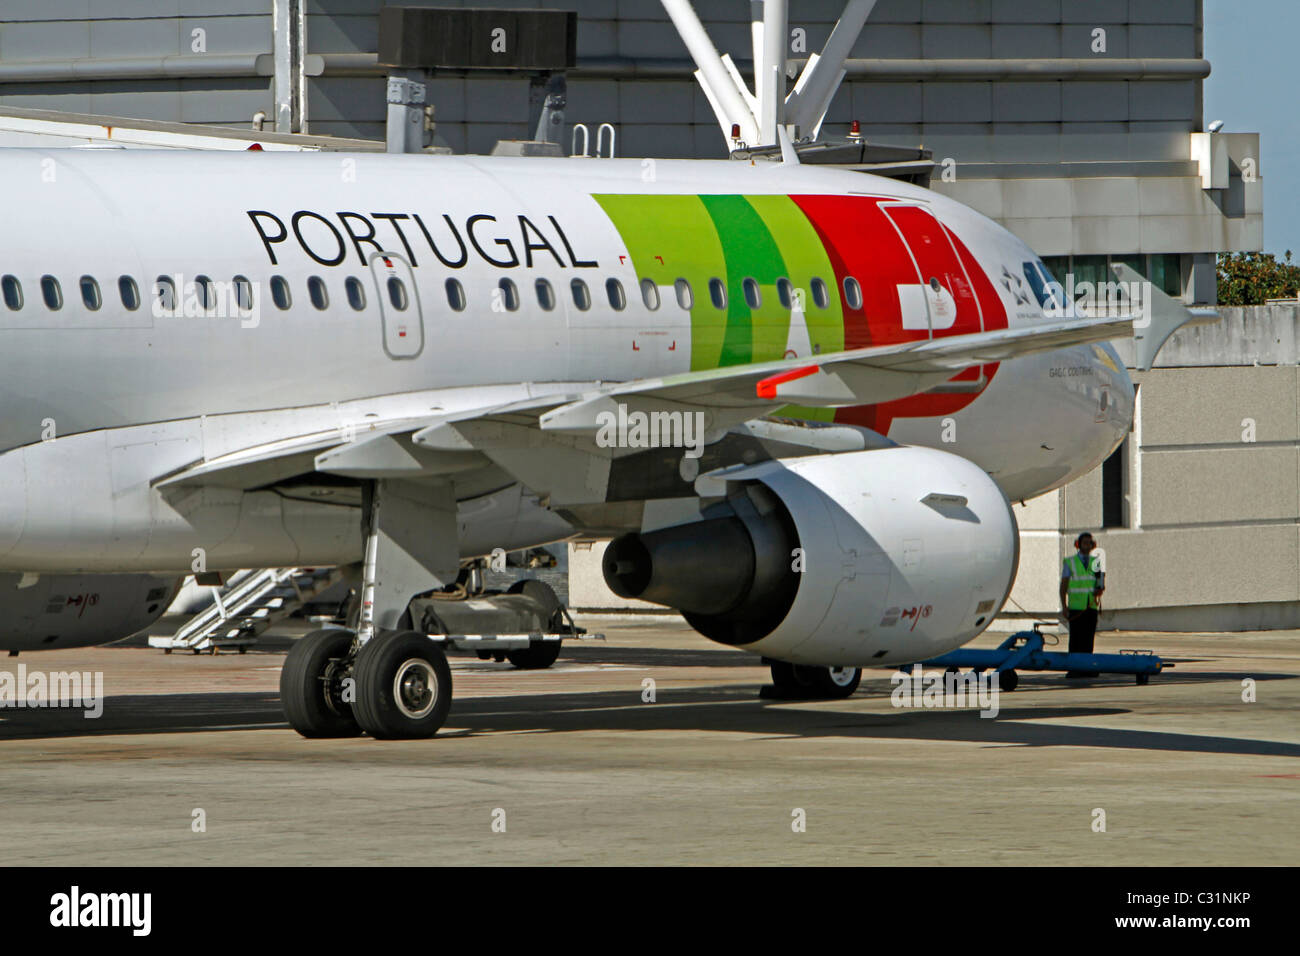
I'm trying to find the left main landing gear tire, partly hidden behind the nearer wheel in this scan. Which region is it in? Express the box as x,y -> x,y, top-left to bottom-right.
280,628 -> 361,737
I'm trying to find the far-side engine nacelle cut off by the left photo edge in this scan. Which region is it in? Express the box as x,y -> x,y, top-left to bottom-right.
0,574 -> 181,650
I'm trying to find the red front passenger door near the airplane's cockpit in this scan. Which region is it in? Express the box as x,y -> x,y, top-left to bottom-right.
881,204 -> 984,338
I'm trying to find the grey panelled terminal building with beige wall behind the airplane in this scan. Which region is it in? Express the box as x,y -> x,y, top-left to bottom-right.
0,0 -> 1279,630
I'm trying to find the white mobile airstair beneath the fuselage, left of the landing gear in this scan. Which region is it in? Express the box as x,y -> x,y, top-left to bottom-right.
150,567 -> 342,654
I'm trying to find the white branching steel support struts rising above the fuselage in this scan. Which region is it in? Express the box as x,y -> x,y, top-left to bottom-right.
660,0 -> 876,156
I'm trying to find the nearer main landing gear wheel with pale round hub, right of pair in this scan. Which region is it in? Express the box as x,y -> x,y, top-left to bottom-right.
352,631 -> 451,740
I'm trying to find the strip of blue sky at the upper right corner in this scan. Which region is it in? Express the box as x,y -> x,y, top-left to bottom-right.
1204,0 -> 1300,258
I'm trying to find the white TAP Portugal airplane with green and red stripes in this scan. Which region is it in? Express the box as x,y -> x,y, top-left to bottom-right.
0,141 -> 1188,737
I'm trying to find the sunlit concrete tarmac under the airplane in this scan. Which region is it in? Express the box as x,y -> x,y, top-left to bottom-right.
0,615 -> 1300,866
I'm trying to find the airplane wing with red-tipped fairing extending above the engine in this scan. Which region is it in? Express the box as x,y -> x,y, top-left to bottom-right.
155,316 -> 1132,503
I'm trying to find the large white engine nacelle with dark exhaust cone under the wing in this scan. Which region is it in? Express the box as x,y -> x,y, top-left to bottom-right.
603,447 -> 1019,666
